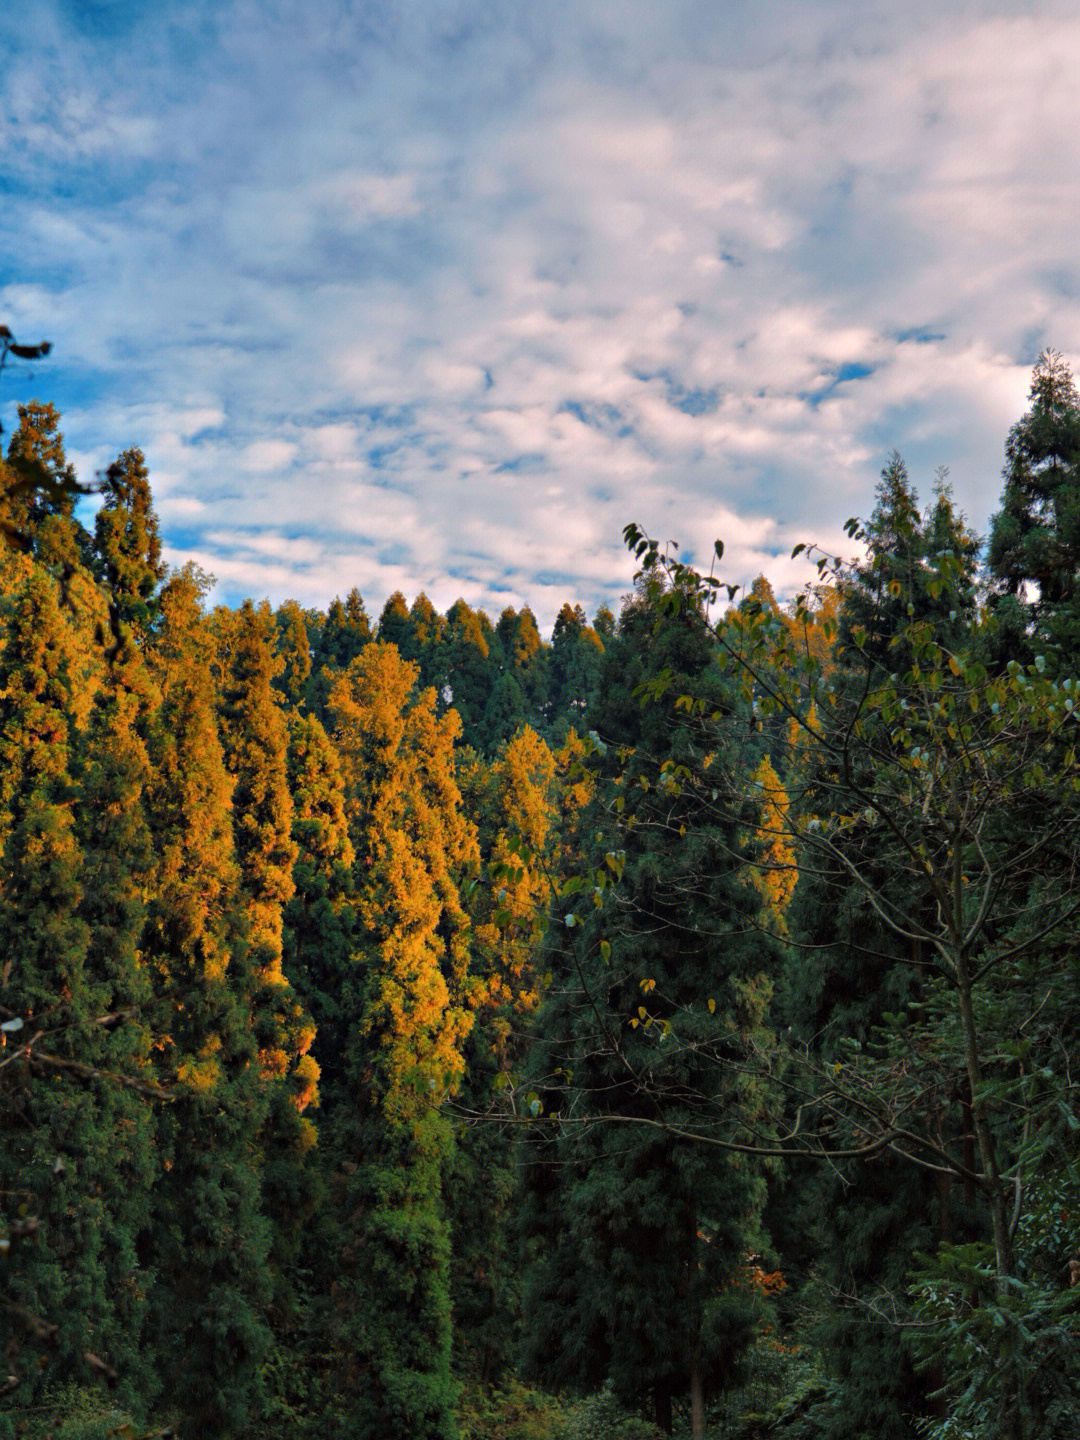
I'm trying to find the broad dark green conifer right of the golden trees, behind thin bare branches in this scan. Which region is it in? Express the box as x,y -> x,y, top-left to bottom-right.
526,578 -> 778,1436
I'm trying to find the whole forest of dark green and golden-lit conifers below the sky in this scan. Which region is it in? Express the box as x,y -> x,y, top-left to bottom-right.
0,334 -> 1080,1440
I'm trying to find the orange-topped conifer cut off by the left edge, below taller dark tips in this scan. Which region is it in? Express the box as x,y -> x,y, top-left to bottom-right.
0,566 -> 105,1403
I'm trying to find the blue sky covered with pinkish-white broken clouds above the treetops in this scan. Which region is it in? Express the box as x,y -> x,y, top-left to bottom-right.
0,0 -> 1080,629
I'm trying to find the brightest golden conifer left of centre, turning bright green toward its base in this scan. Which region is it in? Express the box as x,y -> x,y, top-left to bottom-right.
330,644 -> 475,1440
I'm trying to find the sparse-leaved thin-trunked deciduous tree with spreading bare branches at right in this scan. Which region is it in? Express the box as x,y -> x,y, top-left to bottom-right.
628,524 -> 1080,1440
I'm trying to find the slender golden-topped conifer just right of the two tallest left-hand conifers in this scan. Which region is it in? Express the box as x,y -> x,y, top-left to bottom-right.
145,567 -> 269,1440
